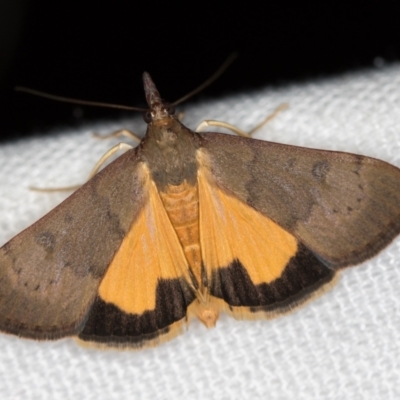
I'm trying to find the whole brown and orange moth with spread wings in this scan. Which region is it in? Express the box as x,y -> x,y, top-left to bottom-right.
0,73 -> 400,348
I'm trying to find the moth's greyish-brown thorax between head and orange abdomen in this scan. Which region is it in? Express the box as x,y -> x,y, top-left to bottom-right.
142,116 -> 200,191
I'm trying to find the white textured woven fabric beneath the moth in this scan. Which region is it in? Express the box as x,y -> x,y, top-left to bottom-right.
0,65 -> 400,400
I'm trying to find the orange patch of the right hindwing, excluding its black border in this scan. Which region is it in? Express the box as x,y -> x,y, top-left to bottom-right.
198,169 -> 298,285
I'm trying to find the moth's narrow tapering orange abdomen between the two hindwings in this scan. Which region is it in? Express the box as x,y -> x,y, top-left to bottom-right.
160,180 -> 201,285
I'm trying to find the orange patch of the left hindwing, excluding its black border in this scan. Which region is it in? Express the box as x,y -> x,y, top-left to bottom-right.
99,164 -> 188,314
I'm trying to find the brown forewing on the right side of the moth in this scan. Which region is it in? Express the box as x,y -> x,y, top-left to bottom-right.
200,133 -> 400,268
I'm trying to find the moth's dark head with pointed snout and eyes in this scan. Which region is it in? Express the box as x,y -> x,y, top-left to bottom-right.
143,72 -> 175,124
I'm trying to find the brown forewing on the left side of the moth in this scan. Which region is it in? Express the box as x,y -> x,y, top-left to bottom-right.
0,149 -> 147,339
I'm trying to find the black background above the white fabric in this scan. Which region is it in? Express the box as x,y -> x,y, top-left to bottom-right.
0,0 -> 400,140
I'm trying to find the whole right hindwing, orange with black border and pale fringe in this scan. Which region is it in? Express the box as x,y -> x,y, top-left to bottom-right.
198,159 -> 337,319
